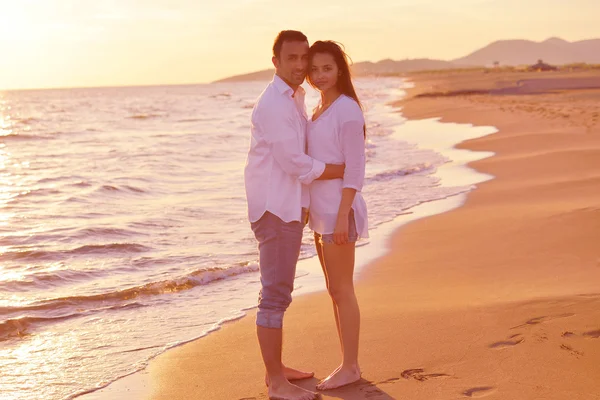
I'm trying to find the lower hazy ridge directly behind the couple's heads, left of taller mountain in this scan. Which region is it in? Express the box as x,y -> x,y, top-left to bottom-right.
217,58 -> 456,82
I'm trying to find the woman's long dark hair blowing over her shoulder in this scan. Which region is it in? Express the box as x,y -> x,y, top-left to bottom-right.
306,40 -> 367,137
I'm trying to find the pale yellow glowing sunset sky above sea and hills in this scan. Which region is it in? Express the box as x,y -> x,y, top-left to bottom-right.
0,0 -> 600,89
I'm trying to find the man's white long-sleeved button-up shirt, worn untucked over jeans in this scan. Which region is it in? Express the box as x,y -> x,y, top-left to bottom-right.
244,75 -> 325,222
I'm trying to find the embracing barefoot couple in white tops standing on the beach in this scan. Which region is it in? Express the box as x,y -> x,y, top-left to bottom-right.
245,31 -> 368,400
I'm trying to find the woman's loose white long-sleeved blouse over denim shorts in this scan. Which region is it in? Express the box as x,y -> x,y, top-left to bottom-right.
307,95 -> 369,238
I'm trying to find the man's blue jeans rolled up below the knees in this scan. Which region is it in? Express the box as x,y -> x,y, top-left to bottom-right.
251,211 -> 305,329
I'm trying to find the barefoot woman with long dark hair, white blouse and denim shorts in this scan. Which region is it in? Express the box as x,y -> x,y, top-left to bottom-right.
307,41 -> 368,390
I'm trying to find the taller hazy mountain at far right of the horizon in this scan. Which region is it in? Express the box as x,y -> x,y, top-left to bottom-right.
452,37 -> 600,66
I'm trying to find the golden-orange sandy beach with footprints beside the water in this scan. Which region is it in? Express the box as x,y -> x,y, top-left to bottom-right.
113,73 -> 600,400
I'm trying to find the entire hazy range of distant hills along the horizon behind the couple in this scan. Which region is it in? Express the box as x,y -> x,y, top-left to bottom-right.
217,37 -> 600,82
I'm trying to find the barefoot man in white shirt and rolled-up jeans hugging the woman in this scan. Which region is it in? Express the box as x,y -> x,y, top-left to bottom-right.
244,31 -> 344,400
